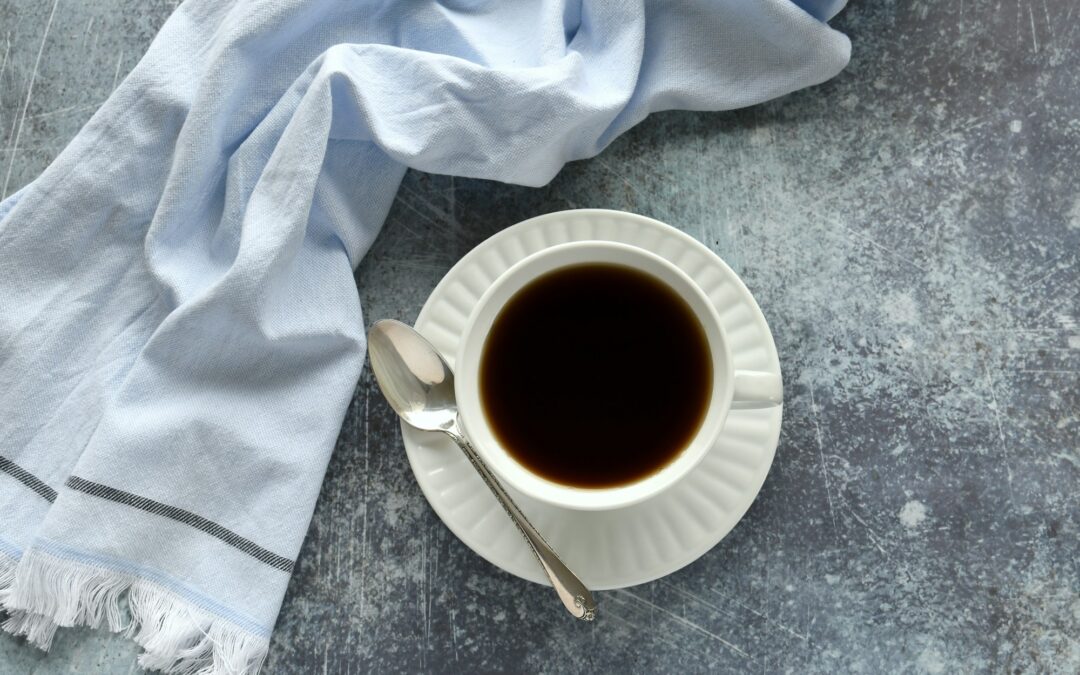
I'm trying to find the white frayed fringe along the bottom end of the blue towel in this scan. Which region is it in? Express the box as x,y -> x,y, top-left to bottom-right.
0,550 -> 269,675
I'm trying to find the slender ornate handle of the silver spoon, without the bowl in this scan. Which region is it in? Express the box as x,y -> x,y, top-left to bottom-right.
446,424 -> 596,621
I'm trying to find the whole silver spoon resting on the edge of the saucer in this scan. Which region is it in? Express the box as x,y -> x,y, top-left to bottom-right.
367,320 -> 596,621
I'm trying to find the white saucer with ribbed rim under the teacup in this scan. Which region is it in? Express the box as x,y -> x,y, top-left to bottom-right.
402,210 -> 783,591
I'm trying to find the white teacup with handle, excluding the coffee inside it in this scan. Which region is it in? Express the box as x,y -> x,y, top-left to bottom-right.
455,241 -> 782,511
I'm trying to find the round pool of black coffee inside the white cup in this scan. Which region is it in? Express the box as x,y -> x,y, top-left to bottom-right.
480,264 -> 713,488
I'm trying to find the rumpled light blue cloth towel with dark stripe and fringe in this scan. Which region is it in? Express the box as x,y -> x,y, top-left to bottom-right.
0,0 -> 850,673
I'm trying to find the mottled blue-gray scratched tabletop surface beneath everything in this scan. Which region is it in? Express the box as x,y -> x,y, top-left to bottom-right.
0,0 -> 1080,673
